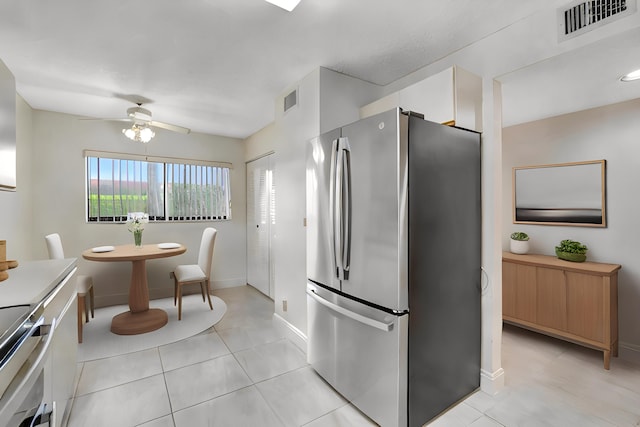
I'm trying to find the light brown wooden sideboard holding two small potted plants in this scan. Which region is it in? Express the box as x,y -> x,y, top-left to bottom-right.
502,252 -> 621,369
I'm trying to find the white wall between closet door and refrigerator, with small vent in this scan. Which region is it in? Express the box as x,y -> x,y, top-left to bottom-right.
245,68 -> 380,346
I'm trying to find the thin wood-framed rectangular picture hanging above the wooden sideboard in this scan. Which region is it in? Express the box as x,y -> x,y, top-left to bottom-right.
513,160 -> 607,227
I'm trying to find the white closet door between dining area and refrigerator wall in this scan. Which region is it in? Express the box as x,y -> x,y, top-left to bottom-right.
247,154 -> 275,298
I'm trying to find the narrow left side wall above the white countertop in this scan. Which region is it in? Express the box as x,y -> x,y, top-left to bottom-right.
0,96 -> 34,260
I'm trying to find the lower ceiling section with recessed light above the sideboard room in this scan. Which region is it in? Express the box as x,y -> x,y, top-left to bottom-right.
499,27 -> 640,126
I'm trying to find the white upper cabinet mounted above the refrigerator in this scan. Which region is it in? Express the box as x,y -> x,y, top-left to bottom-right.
360,66 -> 482,132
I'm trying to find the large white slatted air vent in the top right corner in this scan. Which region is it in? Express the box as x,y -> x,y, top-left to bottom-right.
558,0 -> 636,41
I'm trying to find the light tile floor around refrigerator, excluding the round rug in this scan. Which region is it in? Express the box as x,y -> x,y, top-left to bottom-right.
69,286 -> 640,427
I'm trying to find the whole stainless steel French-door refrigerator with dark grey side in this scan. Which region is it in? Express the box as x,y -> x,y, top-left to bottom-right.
306,109 -> 481,426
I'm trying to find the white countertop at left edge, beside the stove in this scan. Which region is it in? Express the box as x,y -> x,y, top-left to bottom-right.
0,258 -> 77,307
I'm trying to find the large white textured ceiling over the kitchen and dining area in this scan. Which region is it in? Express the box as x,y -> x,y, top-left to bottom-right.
0,0 -> 636,138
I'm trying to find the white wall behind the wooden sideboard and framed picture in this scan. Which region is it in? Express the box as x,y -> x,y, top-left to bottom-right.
502,99 -> 640,363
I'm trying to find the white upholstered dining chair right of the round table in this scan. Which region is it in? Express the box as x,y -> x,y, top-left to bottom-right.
173,227 -> 218,320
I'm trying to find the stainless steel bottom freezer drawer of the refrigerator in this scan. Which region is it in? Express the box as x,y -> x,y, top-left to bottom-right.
307,283 -> 409,426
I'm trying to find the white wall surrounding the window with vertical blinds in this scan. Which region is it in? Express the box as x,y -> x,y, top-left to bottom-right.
24,111 -> 246,306
